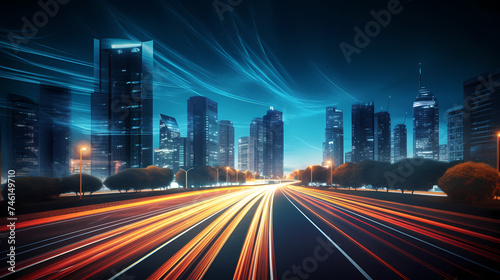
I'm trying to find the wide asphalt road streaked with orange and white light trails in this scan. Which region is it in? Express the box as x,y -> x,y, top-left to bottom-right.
0,185 -> 500,280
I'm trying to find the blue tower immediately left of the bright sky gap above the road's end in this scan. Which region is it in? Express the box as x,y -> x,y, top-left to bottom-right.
262,107 -> 284,178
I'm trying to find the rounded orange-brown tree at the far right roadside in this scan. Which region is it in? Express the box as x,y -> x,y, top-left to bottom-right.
438,161 -> 500,204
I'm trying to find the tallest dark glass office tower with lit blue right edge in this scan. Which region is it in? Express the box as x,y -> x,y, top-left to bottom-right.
91,39 -> 153,178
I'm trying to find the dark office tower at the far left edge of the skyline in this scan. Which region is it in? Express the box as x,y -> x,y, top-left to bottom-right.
7,94 -> 40,177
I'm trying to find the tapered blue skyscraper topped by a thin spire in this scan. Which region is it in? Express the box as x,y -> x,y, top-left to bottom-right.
413,64 -> 439,160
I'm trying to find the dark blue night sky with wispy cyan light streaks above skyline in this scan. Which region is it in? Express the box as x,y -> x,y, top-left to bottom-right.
0,0 -> 500,172
